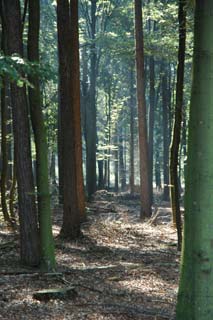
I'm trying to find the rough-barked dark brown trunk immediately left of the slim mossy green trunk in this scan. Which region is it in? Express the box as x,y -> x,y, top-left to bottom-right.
2,0 -> 40,265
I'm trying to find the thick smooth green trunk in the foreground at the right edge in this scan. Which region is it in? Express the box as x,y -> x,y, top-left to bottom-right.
176,0 -> 213,320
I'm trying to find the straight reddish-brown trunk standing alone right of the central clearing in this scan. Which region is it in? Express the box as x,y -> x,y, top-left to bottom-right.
135,0 -> 151,218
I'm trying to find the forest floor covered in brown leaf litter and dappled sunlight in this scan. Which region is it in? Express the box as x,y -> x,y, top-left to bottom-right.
0,191 -> 180,320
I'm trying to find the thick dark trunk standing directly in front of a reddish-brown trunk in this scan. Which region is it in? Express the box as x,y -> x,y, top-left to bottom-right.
57,0 -> 81,239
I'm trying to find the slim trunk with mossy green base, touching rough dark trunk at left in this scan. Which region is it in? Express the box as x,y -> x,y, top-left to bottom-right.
27,0 -> 55,270
